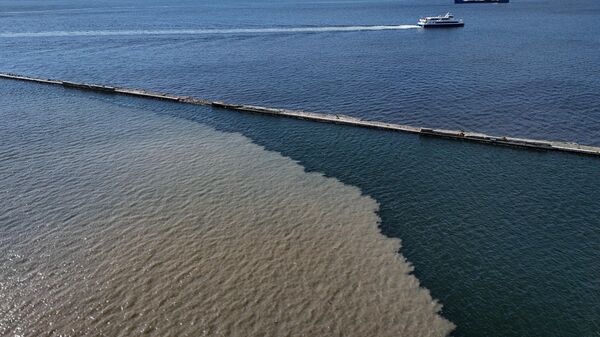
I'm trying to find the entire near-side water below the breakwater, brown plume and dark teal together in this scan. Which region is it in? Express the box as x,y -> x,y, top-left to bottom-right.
0,82 -> 600,336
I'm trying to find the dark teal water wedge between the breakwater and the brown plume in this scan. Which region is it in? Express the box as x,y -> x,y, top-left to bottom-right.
25,86 -> 600,336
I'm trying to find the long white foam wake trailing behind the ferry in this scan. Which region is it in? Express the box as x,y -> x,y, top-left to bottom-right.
0,25 -> 419,38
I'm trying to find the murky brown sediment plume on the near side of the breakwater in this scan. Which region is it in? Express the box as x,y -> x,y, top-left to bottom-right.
0,87 -> 453,336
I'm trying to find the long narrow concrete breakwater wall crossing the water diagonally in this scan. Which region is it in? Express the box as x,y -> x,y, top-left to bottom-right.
0,73 -> 600,157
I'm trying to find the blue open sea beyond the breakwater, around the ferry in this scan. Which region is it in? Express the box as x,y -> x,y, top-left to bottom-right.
0,0 -> 600,145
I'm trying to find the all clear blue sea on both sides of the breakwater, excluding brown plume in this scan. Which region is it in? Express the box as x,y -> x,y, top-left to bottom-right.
0,0 -> 600,336
